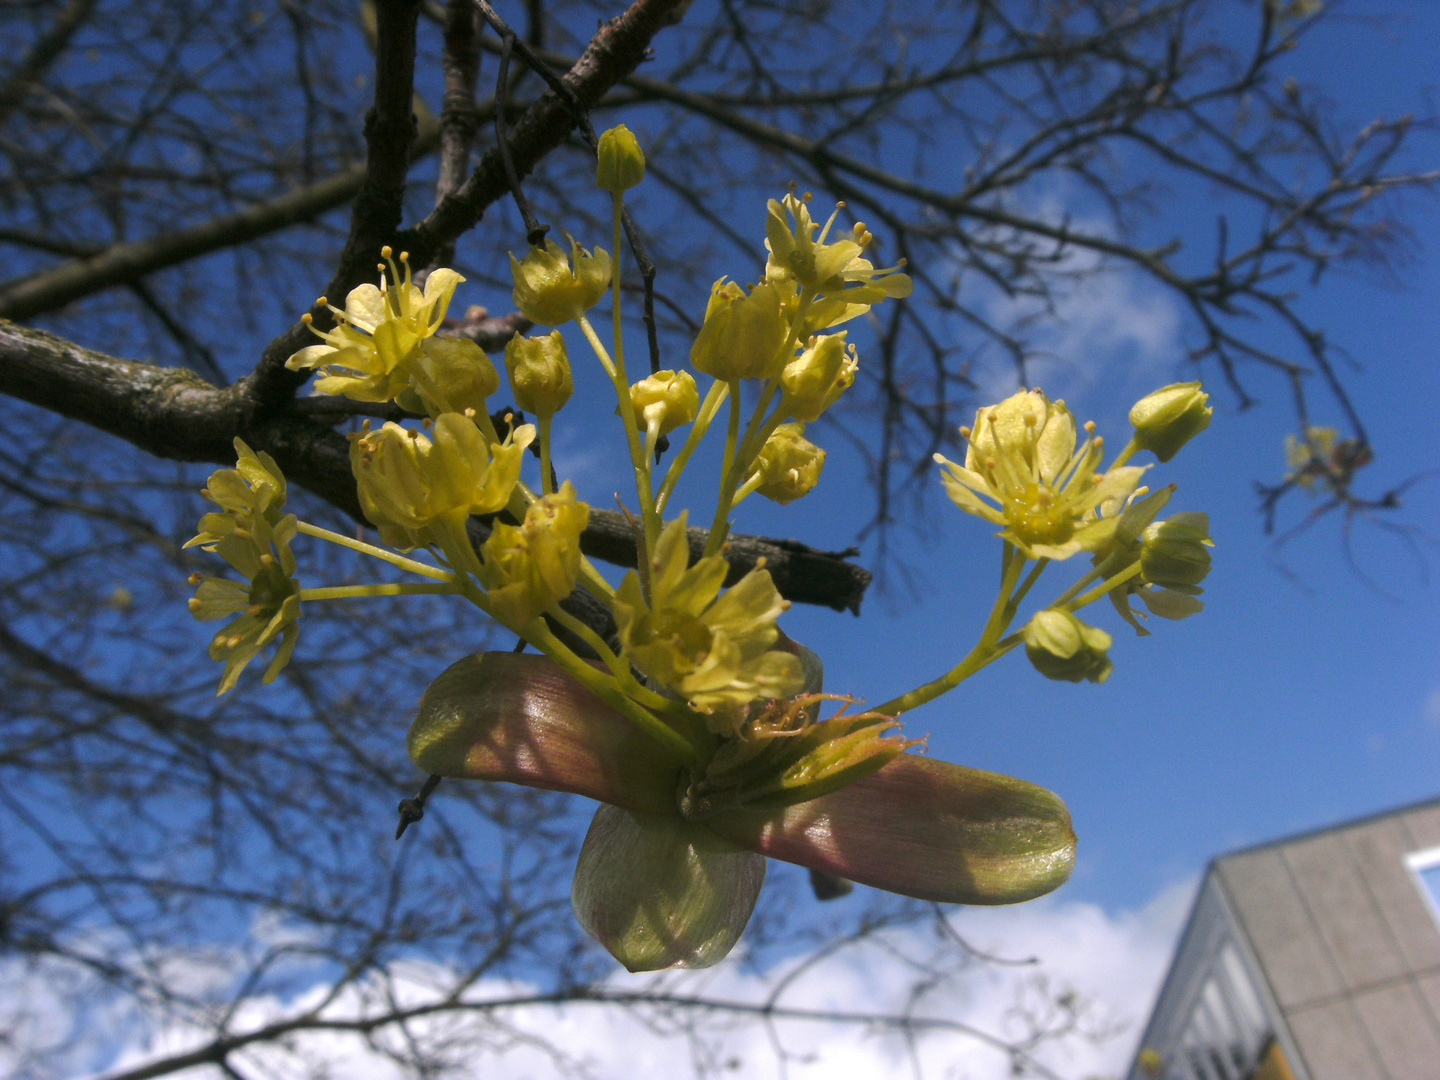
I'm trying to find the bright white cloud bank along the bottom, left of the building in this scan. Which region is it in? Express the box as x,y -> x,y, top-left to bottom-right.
8,886 -> 1194,1080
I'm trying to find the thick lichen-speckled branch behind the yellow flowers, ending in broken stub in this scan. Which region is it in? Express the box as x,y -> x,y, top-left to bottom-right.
0,320 -> 870,612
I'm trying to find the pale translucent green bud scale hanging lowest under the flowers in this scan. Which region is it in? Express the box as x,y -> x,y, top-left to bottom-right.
570,806 -> 765,972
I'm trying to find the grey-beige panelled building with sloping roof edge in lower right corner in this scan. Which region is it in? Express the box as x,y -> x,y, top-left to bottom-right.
1128,799 -> 1440,1080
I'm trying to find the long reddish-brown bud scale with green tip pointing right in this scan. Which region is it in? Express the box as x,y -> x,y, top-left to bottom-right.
706,755 -> 1076,904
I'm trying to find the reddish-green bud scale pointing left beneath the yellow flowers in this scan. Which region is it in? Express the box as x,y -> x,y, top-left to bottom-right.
406,652 -> 680,814
